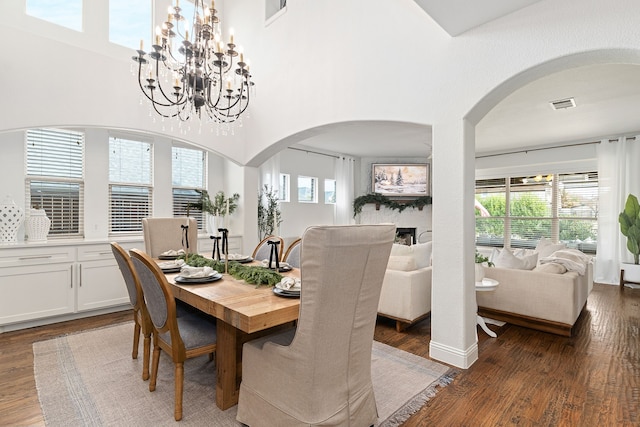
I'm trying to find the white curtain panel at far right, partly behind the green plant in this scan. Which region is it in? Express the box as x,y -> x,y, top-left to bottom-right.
593,135 -> 640,284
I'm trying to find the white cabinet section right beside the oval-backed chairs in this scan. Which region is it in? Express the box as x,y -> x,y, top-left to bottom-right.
76,244 -> 129,311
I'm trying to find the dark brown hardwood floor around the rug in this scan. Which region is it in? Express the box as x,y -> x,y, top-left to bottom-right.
0,284 -> 640,427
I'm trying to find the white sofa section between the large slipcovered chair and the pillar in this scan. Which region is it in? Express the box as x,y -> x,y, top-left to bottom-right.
378,242 -> 432,332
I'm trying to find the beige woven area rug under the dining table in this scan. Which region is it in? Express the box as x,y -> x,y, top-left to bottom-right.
33,323 -> 454,427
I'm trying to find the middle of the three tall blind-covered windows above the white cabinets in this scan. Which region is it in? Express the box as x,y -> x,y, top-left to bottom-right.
109,137 -> 153,233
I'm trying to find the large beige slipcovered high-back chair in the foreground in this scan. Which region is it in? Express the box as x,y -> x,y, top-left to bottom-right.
237,224 -> 395,427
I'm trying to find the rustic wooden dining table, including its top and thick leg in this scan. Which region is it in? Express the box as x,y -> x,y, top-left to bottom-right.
161,261 -> 300,410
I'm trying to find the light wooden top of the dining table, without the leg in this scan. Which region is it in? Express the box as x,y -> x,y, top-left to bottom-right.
166,264 -> 300,333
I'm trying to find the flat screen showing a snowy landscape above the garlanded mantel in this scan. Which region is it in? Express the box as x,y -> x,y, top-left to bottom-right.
371,163 -> 429,197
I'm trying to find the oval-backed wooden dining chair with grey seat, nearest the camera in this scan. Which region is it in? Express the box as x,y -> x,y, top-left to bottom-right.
130,249 -> 216,421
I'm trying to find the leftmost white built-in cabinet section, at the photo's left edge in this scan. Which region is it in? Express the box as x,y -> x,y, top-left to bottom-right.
0,247 -> 75,325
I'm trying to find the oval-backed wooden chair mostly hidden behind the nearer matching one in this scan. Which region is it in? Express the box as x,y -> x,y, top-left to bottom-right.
111,242 -> 153,381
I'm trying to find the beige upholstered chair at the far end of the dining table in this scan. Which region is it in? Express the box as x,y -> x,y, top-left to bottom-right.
142,217 -> 198,258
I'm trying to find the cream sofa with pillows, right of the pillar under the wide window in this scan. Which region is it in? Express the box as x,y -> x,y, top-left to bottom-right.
476,239 -> 593,336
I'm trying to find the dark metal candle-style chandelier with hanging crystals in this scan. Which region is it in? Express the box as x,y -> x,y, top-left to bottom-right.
133,0 -> 254,123
